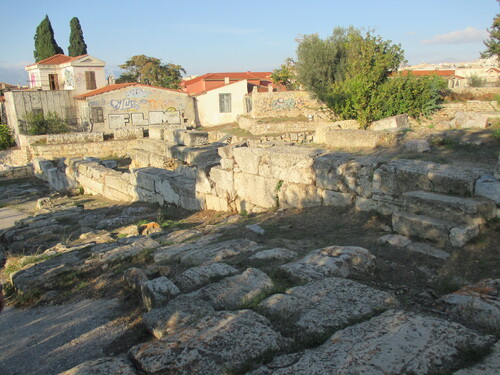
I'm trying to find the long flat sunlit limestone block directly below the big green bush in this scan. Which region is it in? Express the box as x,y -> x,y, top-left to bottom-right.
314,129 -> 386,148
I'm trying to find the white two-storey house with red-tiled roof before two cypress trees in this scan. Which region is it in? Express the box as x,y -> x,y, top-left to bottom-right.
25,54 -> 106,95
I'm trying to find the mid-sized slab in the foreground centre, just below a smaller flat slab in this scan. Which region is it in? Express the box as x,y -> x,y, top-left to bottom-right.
191,268 -> 274,310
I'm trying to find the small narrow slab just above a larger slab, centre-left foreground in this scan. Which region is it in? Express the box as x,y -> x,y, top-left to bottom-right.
174,263 -> 239,293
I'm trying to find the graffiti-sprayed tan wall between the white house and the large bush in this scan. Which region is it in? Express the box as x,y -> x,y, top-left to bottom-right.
250,91 -> 333,120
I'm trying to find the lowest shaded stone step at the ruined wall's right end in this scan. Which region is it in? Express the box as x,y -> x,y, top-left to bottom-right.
392,212 -> 479,247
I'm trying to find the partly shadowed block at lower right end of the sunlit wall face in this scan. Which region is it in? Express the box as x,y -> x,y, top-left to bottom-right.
277,182 -> 323,208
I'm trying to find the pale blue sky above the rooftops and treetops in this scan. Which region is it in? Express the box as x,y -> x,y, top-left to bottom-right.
0,0 -> 500,84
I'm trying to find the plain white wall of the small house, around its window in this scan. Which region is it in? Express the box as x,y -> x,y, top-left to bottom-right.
196,80 -> 248,126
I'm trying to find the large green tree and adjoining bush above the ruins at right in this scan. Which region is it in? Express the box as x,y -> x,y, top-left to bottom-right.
296,27 -> 446,128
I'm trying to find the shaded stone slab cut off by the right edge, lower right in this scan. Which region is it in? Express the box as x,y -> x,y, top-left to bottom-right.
438,279 -> 500,334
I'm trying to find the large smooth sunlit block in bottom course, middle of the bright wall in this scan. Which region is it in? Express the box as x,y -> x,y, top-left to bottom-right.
234,173 -> 279,208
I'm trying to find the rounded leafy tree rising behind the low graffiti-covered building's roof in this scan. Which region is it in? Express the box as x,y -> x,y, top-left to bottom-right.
116,55 -> 186,89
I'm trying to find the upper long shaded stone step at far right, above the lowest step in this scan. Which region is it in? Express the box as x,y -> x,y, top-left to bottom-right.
402,191 -> 496,225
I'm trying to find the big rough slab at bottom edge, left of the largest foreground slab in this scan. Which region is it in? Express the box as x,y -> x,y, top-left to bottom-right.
129,310 -> 287,375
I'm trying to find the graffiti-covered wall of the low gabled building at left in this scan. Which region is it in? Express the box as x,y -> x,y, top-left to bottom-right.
78,86 -> 196,133
